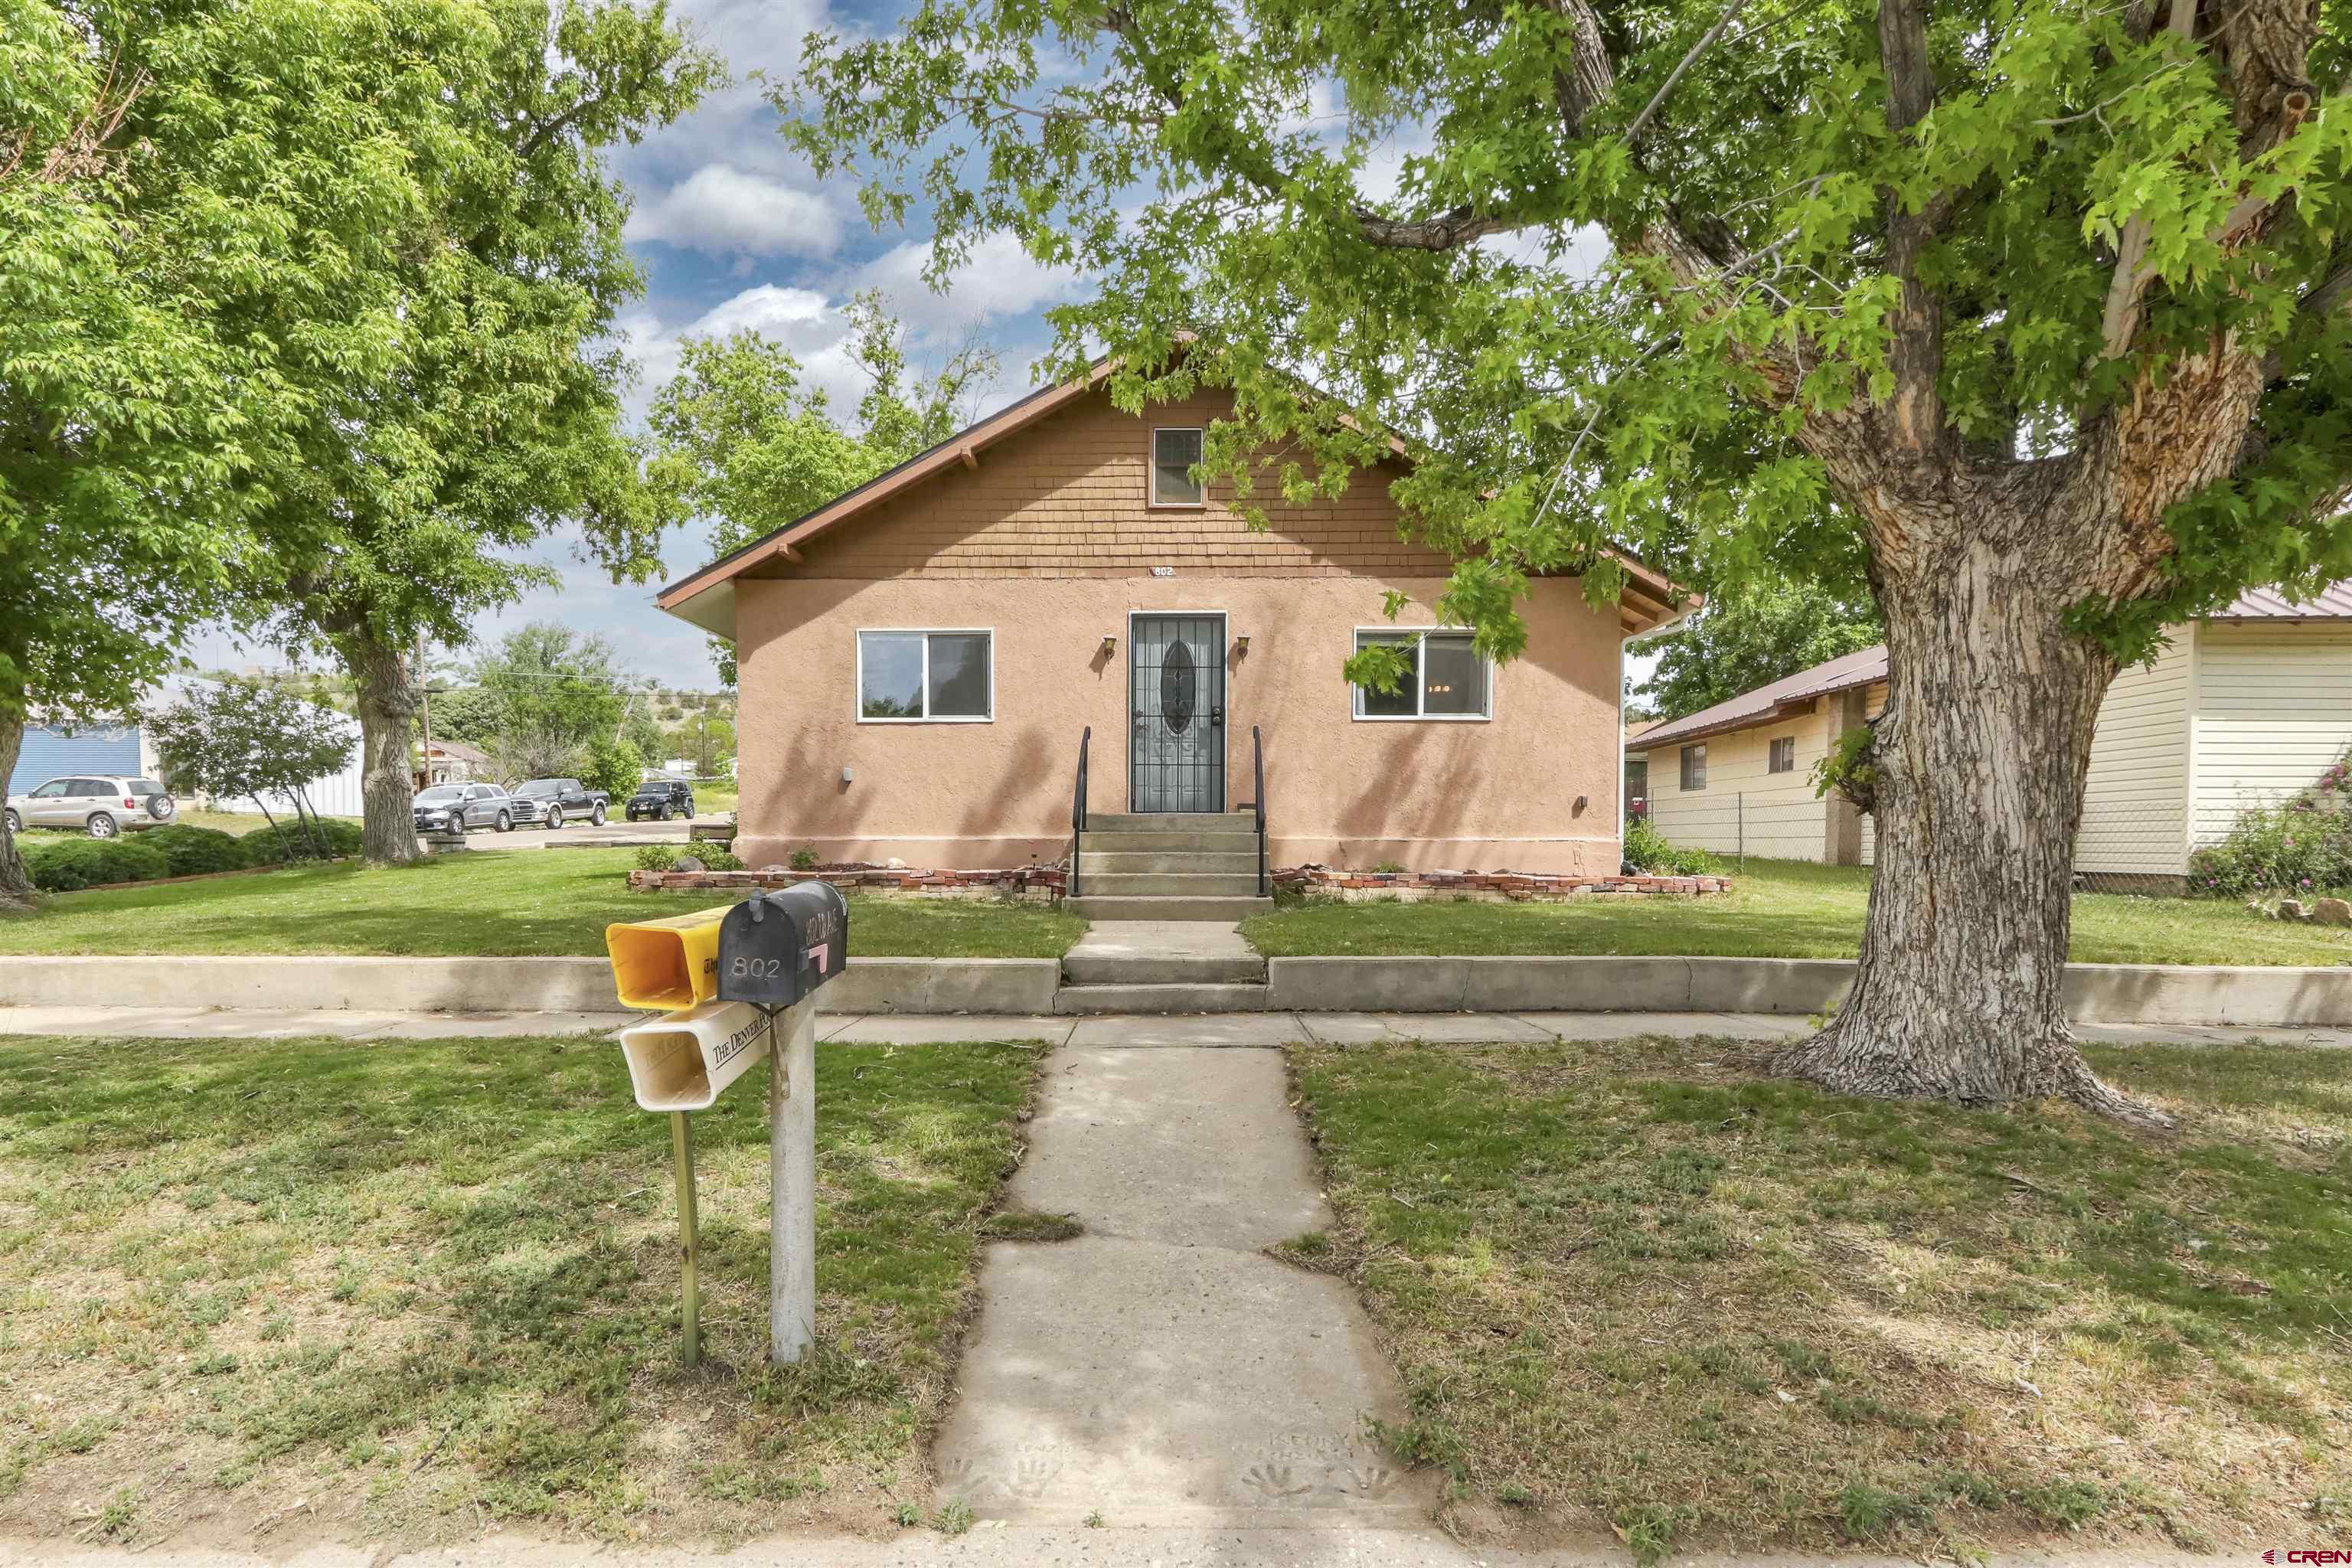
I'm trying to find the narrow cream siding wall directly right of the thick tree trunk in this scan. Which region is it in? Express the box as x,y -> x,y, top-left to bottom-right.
2075,626 -> 2209,877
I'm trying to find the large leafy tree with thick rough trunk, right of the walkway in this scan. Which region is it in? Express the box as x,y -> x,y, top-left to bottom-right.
779,0 -> 2352,1116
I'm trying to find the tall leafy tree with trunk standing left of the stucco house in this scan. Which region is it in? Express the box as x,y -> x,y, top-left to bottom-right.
252,0 -> 722,863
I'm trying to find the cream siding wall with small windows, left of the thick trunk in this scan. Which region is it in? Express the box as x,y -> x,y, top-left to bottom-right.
1648,703 -> 1828,861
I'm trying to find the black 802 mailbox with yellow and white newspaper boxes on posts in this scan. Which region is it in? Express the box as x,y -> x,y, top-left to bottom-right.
605,881 -> 849,1366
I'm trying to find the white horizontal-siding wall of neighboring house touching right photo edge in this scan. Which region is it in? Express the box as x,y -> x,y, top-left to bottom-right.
2192,621 -> 2352,844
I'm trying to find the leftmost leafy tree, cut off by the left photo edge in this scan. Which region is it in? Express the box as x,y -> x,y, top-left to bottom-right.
0,0 -> 453,907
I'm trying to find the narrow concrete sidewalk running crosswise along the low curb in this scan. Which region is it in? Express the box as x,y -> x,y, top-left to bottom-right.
18,1006 -> 2352,1046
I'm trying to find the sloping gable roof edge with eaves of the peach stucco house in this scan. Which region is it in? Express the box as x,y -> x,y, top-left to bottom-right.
654,358 -> 1698,637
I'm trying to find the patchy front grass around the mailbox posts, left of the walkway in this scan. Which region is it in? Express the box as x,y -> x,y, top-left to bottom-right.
0,1037 -> 1040,1544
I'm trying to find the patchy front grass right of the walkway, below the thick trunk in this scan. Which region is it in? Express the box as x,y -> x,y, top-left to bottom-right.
1282,1039 -> 2352,1561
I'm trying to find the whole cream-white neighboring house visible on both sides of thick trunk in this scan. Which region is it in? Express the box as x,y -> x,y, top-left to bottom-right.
1635,580 -> 2352,891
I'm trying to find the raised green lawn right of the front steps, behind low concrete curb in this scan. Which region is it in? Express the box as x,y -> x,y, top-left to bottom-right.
1242,861 -> 2352,964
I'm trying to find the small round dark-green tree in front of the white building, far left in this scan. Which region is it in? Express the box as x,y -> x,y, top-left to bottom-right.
139,681 -> 360,856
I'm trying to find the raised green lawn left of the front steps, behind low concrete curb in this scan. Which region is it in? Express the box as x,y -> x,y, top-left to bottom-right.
0,848 -> 1086,959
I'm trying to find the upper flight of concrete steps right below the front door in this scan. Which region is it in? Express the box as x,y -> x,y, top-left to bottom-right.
1068,811 -> 1275,926
